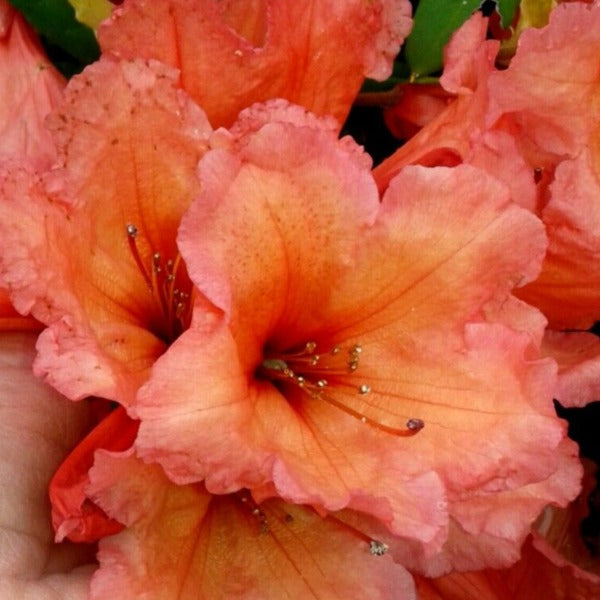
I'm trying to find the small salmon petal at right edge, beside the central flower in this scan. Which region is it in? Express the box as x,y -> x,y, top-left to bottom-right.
542,331 -> 600,407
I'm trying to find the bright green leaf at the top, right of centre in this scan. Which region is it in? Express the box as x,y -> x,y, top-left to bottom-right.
405,0 -> 482,77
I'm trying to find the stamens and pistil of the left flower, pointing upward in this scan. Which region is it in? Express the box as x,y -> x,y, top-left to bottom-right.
125,223 -> 192,343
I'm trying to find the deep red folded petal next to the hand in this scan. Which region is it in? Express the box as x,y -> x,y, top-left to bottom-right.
49,407 -> 139,542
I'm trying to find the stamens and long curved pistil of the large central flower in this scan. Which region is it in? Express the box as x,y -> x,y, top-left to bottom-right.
259,342 -> 425,437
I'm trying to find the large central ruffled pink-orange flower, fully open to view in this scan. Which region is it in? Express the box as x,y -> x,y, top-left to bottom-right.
130,102 -> 579,564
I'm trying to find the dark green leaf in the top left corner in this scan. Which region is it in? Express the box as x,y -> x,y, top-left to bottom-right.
9,0 -> 100,70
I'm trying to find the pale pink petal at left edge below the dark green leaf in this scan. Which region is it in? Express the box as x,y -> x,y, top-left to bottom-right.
0,8 -> 66,168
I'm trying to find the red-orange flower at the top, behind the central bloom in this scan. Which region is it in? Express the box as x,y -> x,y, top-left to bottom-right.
98,0 -> 412,127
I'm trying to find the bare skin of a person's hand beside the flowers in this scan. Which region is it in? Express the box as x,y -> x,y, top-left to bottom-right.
0,332 -> 94,600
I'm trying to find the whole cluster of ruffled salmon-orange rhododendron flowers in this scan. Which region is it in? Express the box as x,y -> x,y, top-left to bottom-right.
0,0 -> 600,600
